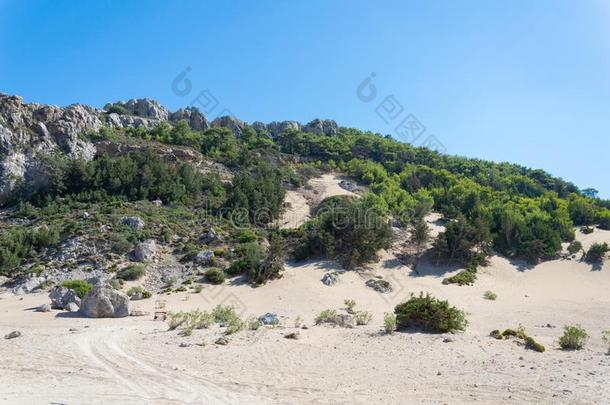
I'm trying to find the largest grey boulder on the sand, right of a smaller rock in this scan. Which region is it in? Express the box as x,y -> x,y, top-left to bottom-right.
79,283 -> 129,318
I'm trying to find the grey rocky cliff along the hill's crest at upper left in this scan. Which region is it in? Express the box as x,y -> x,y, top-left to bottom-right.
0,93 -> 338,204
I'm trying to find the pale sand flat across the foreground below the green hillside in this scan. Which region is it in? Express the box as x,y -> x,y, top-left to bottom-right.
0,177 -> 610,404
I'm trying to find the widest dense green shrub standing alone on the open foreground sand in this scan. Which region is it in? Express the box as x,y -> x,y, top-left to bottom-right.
394,293 -> 468,333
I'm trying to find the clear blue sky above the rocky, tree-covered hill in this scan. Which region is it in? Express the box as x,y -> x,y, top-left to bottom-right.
0,0 -> 610,198
